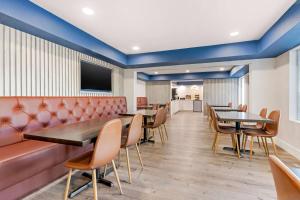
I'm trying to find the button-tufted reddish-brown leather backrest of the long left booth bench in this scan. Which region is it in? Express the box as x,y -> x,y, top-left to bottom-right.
0,97 -> 127,147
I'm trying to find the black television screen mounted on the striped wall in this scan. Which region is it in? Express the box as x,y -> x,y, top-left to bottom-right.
80,61 -> 112,92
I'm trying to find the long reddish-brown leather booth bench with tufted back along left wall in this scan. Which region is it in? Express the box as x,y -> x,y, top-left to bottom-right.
0,97 -> 127,200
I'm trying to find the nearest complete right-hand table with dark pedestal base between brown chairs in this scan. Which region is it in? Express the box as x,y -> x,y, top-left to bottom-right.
217,112 -> 273,154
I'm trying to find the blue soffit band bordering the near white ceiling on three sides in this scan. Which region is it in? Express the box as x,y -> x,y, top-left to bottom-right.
0,0 -> 300,68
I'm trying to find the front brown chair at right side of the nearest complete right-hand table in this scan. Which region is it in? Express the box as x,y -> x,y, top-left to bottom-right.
243,110 -> 280,159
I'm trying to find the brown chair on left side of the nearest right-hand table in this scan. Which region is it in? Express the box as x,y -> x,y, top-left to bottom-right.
212,109 -> 240,158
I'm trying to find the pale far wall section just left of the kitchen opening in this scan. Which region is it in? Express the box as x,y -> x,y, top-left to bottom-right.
146,81 -> 171,103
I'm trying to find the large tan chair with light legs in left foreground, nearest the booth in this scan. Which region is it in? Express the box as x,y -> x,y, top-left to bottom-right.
64,119 -> 123,200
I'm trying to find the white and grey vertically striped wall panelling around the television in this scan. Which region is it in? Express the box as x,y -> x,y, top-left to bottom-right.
0,24 -> 123,96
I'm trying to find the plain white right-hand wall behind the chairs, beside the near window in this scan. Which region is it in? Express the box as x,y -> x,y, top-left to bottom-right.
249,52 -> 300,159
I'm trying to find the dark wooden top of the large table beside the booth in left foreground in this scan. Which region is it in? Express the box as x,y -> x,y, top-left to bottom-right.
24,117 -> 132,146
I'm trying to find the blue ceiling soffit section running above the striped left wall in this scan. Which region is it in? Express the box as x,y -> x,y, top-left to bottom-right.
0,0 -> 127,65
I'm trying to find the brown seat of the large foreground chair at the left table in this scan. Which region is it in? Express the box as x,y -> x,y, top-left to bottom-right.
65,151 -> 93,170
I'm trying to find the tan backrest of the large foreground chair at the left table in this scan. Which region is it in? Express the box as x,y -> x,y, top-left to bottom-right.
90,119 -> 122,169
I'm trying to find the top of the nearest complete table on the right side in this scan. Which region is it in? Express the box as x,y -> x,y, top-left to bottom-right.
217,112 -> 272,123
